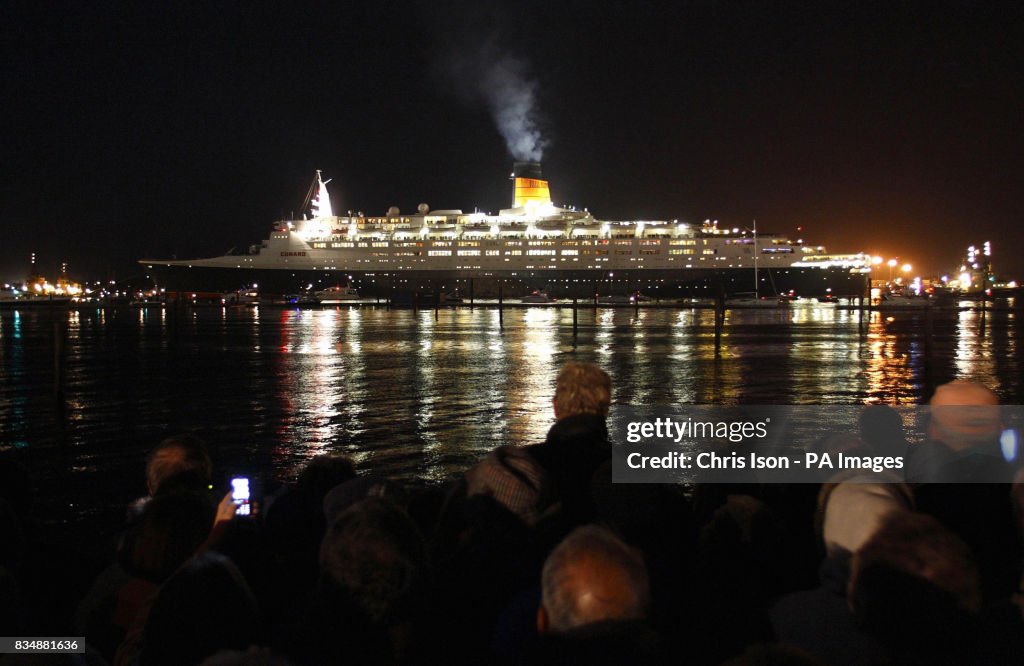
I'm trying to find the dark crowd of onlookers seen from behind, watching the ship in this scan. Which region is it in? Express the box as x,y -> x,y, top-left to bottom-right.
0,363 -> 1024,666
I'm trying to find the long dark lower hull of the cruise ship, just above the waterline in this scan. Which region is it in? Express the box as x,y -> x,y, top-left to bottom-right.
142,264 -> 867,298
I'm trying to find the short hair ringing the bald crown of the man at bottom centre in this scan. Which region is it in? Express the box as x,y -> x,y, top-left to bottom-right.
542,525 -> 650,633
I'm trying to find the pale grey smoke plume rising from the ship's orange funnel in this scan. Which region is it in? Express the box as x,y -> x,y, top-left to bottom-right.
479,55 -> 547,162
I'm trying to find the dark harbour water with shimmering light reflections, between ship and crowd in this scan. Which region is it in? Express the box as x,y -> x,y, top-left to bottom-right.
0,302 -> 1024,521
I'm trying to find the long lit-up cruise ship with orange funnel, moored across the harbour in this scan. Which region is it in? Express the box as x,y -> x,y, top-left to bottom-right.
139,162 -> 870,298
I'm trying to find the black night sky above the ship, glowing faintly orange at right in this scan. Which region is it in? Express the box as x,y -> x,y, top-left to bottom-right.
0,0 -> 1024,277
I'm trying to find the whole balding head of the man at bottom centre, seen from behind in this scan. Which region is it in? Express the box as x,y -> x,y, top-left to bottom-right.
538,525 -> 650,633
